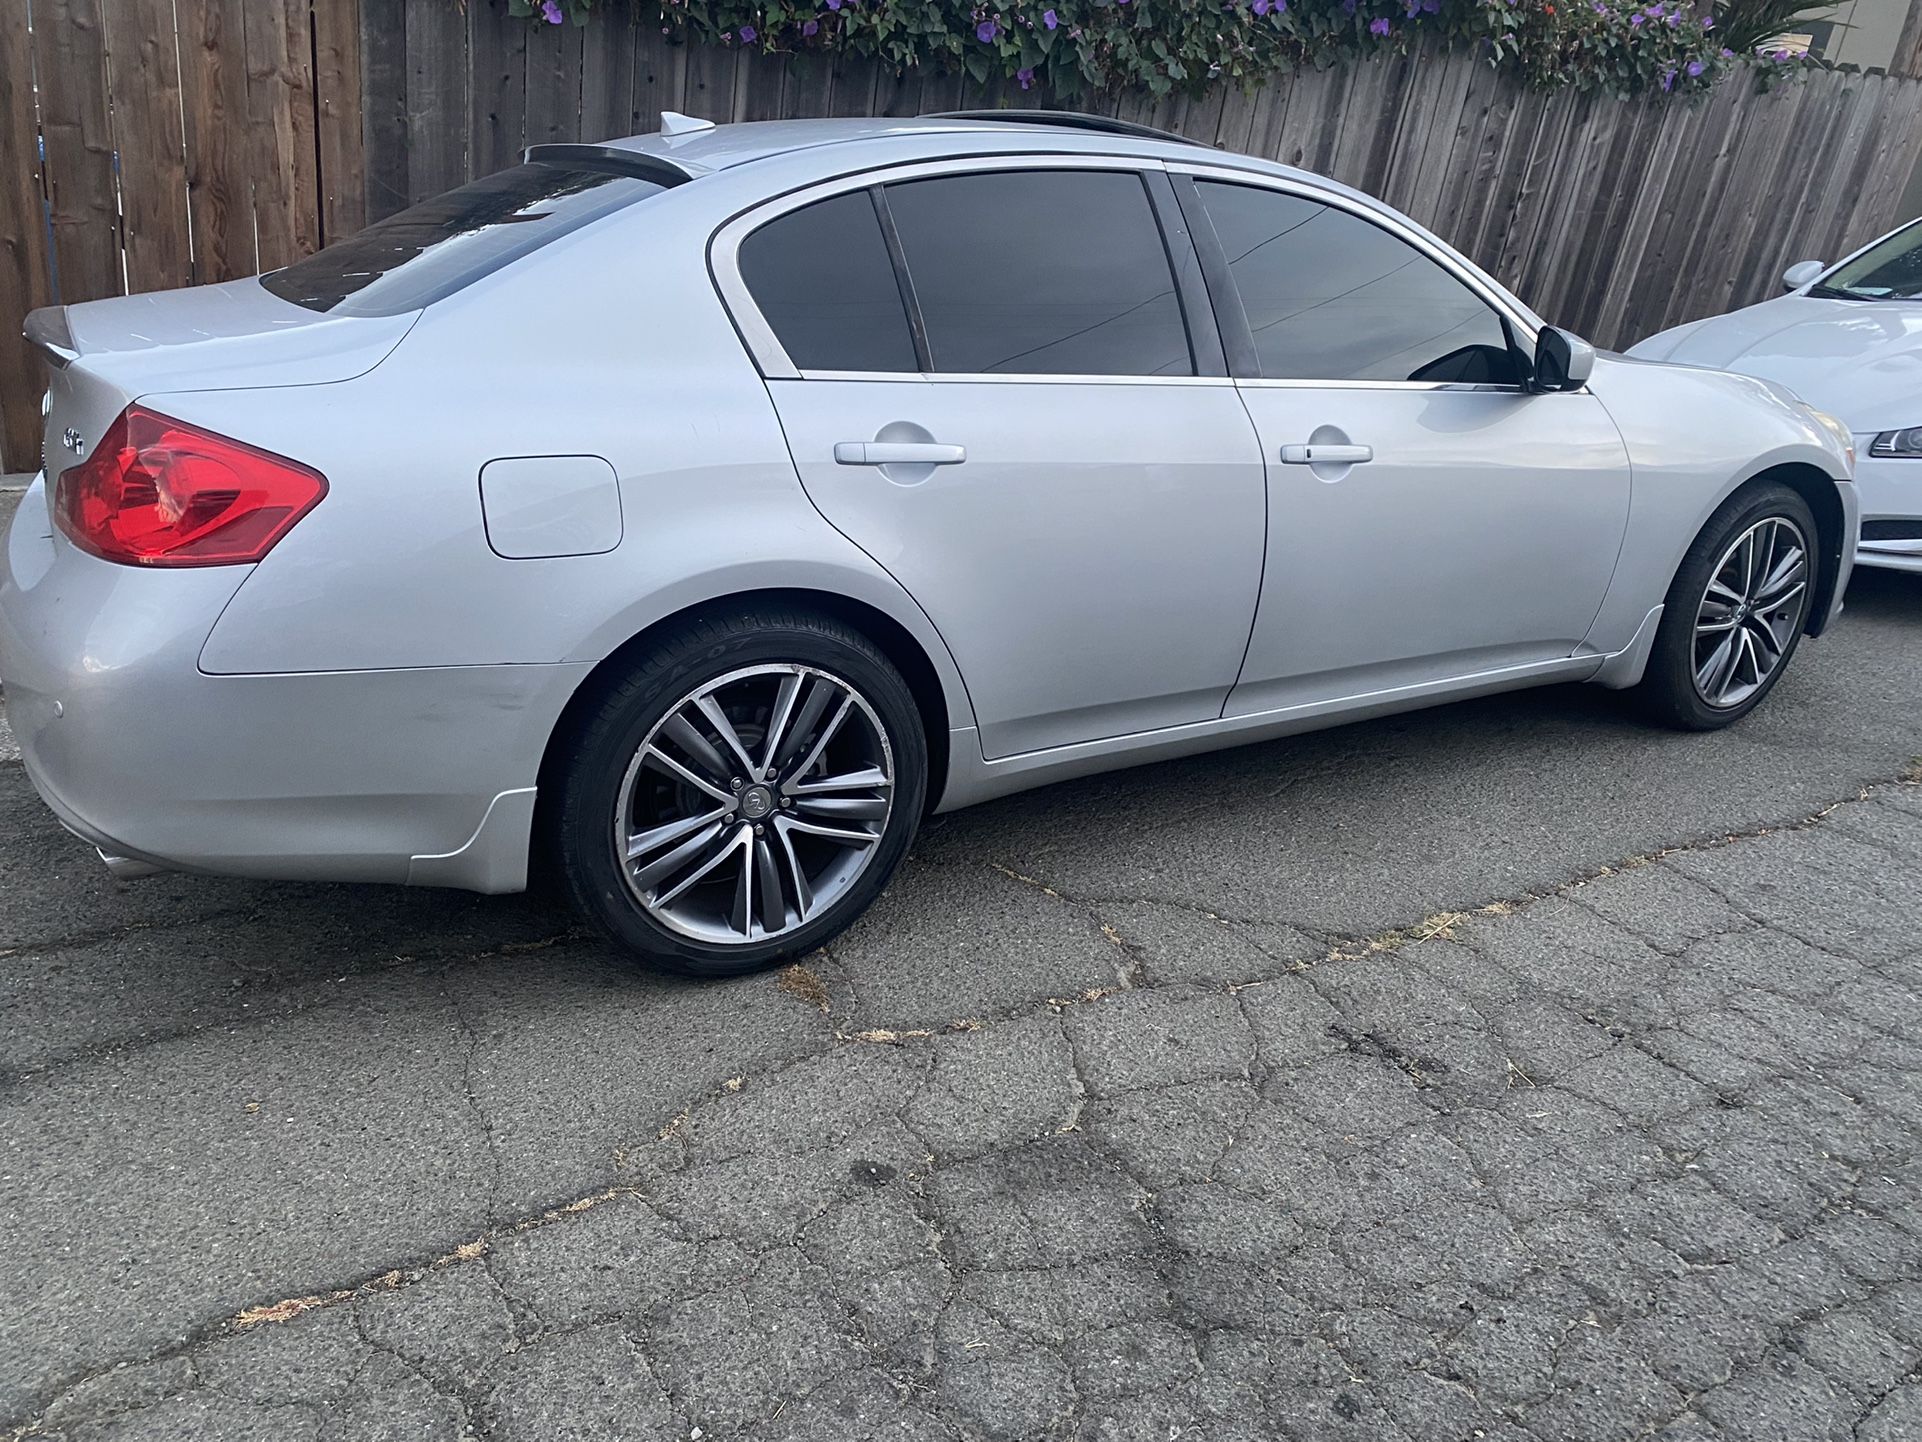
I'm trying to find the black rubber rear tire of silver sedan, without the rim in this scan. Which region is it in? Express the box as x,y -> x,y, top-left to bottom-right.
550,608 -> 928,977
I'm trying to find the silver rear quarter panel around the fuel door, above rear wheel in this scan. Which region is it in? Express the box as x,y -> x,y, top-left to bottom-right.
187,186 -> 971,745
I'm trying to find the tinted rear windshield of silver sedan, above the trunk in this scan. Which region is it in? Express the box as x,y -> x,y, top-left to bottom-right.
261,162 -> 665,315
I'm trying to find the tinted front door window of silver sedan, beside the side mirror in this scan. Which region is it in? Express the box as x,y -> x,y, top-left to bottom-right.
1199,181 -> 1518,385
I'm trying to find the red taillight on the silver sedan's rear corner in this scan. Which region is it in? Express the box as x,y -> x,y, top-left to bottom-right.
54,406 -> 327,565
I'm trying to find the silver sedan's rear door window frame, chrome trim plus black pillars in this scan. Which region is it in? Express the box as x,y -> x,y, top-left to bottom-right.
707,154 -> 1234,386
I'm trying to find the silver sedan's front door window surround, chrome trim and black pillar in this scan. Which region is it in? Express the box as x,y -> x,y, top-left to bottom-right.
1167,162 -> 1540,396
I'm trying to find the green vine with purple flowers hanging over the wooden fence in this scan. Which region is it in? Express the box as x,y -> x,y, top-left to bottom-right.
507,0 -> 1778,100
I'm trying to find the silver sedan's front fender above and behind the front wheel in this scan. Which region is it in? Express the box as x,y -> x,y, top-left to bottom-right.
1589,356 -> 1845,652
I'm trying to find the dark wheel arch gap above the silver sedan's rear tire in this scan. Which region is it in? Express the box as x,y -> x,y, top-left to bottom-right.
534,586 -> 971,836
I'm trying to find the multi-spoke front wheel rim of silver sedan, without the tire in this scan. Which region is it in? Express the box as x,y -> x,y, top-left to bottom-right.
1693,515 -> 1809,709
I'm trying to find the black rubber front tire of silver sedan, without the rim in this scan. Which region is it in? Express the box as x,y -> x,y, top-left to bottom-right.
1636,481 -> 1820,731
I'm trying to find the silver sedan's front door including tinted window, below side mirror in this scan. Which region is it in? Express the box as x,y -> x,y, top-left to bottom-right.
1176,171 -> 1630,715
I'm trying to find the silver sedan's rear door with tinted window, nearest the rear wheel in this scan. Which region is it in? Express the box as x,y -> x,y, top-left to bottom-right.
715,156 -> 1267,758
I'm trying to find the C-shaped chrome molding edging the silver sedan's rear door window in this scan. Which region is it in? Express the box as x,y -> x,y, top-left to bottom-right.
707,154 -> 1176,385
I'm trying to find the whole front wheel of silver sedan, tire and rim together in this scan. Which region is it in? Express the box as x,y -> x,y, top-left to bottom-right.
1639,483 -> 1818,731
